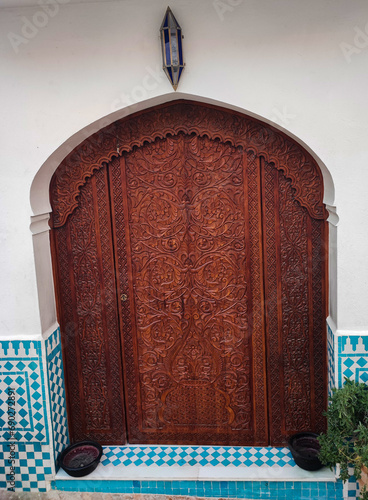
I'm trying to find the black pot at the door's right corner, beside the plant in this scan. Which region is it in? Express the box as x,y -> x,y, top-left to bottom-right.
289,432 -> 323,471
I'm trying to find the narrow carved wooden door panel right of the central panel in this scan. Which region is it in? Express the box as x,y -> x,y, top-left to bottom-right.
260,158 -> 327,444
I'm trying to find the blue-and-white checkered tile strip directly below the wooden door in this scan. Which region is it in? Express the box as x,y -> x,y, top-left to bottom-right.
101,445 -> 295,467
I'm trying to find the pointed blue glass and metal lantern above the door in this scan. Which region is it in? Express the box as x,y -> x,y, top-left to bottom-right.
160,7 -> 184,90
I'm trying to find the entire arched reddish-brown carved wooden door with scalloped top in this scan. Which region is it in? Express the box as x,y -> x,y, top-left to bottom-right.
50,101 -> 327,445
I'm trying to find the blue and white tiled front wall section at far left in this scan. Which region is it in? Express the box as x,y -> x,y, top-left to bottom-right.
0,340 -> 52,492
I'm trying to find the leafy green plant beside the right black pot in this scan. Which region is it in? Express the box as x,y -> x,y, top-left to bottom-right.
319,378 -> 368,500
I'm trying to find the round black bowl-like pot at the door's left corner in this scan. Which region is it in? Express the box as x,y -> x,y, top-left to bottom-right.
58,441 -> 103,477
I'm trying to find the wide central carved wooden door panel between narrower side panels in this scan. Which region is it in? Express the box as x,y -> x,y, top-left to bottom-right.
112,135 -> 267,444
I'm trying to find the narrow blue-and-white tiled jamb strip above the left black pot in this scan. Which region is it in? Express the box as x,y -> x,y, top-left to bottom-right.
46,328 -> 69,459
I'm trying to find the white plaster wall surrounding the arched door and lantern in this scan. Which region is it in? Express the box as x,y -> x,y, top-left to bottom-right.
0,0 -> 368,337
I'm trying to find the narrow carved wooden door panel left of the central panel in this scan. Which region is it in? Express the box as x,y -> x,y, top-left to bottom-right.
53,168 -> 126,444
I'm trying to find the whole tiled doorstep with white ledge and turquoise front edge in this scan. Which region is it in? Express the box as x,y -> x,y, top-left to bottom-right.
53,445 -> 342,500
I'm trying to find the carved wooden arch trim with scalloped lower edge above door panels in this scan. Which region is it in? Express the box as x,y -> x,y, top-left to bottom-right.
50,101 -> 328,227
